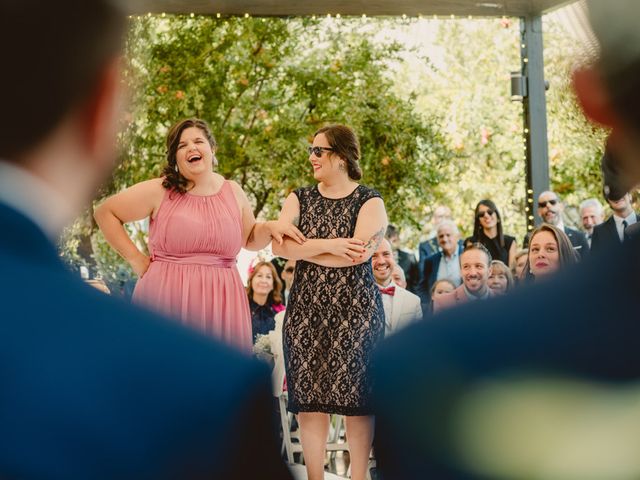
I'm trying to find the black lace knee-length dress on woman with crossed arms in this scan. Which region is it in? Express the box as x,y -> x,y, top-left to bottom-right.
283,185 -> 384,415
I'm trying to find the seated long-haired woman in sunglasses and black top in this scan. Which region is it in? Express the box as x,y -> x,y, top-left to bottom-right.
465,200 -> 518,265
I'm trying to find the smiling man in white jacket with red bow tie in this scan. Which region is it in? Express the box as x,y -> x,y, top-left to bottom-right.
371,239 -> 422,335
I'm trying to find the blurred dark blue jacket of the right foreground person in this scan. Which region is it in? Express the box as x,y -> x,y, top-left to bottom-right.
374,232 -> 640,480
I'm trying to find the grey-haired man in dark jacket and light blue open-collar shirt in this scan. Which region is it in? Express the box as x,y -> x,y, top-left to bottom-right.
416,220 -> 463,304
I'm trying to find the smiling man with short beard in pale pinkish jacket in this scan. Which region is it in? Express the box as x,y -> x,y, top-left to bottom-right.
433,243 -> 493,313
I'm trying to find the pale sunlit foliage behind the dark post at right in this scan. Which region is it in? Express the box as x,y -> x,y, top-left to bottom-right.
395,15 -> 604,239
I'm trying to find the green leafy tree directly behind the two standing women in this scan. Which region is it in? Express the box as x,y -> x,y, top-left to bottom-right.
62,16 -> 448,284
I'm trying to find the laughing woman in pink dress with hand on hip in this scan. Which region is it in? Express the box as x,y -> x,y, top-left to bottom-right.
95,119 -> 304,352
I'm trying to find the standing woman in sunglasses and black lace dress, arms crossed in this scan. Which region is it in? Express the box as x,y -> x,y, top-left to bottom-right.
273,125 -> 387,480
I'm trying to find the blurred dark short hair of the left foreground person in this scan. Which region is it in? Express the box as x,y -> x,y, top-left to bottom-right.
0,0 -> 126,161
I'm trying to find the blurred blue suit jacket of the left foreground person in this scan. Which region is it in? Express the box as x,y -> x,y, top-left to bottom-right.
0,204 -> 290,480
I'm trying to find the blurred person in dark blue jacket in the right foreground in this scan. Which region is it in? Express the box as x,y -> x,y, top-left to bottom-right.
374,0 -> 640,480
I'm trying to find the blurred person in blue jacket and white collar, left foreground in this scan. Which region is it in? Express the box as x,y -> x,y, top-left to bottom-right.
0,0 -> 290,480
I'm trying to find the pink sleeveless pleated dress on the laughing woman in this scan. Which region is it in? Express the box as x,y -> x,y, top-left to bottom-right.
133,181 -> 251,352
